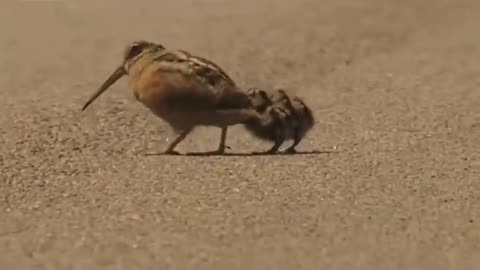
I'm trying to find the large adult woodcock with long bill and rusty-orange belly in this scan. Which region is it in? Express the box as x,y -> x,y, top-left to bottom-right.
82,40 -> 265,155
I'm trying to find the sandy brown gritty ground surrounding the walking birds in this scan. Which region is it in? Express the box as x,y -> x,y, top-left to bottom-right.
0,0 -> 480,270
